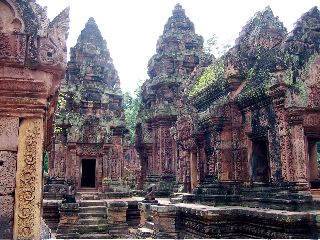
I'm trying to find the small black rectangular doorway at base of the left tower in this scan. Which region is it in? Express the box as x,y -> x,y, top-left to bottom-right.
81,159 -> 96,188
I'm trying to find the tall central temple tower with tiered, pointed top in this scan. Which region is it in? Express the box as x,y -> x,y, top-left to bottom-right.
136,4 -> 208,194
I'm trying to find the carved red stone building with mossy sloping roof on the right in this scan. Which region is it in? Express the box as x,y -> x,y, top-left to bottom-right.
177,5 -> 319,204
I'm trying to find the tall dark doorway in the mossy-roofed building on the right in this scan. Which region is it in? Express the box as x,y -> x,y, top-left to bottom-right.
252,139 -> 269,183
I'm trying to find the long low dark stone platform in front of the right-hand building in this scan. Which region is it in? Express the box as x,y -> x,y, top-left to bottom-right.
136,199 -> 320,239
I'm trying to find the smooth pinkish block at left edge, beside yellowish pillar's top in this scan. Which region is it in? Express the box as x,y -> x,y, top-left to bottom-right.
0,117 -> 19,151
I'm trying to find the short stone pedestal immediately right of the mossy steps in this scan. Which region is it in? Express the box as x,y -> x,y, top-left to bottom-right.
107,201 -> 128,238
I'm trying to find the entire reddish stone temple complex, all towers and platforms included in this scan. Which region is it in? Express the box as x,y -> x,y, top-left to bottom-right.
0,0 -> 320,239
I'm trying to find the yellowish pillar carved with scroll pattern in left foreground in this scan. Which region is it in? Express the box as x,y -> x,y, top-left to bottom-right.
13,118 -> 43,239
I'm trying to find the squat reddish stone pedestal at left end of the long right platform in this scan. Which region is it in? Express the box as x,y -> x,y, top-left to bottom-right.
151,205 -> 178,239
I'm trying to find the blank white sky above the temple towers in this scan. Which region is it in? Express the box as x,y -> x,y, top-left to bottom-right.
37,0 -> 320,93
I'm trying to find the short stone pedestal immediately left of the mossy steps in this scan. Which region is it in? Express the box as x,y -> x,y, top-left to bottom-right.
57,203 -> 80,238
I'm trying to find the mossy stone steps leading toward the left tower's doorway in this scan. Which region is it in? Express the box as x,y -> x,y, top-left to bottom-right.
79,200 -> 110,239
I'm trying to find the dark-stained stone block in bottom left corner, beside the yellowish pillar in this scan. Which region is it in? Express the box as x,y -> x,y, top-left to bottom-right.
0,196 -> 14,239
